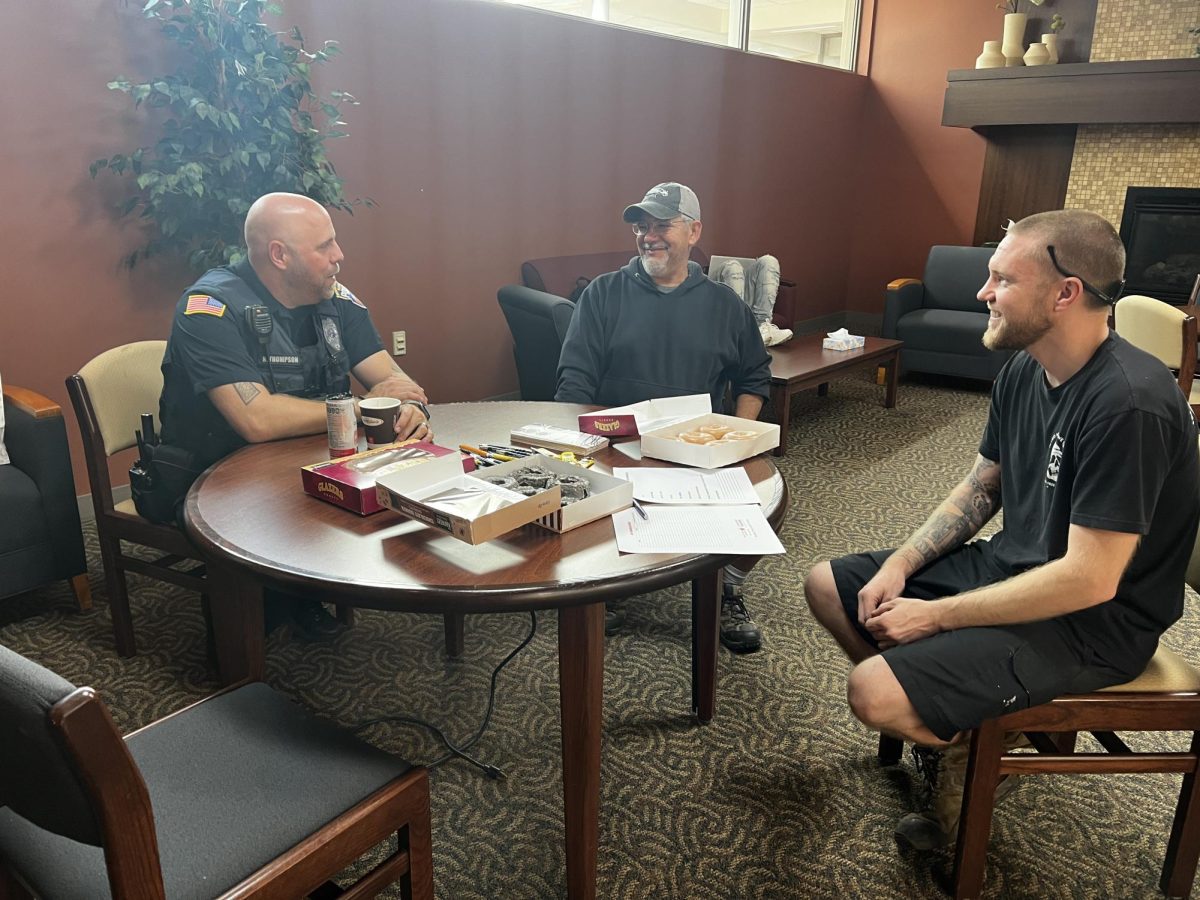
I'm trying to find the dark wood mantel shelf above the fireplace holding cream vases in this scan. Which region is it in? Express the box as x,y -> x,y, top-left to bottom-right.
942,59 -> 1200,128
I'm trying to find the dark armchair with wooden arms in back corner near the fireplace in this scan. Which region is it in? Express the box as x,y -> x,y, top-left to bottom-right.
883,246 -> 1012,382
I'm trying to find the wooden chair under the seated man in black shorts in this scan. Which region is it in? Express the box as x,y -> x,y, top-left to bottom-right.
878,451 -> 1200,898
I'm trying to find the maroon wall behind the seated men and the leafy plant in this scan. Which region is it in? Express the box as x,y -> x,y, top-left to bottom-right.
0,0 -> 1000,492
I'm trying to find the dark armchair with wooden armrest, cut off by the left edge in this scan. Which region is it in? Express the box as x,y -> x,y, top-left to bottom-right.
0,384 -> 91,610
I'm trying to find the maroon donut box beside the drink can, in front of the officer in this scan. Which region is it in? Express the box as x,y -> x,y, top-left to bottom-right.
300,440 -> 475,516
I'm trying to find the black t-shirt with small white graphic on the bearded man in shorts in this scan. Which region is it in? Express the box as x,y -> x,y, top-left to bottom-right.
979,334 -> 1200,674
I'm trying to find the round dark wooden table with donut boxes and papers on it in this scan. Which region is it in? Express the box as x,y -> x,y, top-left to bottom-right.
185,402 -> 788,898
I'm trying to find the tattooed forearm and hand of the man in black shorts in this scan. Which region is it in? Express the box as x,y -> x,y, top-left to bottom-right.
858,456 -> 1001,624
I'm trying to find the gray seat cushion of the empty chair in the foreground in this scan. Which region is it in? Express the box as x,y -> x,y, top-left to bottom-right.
0,683 -> 410,900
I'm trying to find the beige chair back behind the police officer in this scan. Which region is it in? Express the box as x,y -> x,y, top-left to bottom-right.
79,341 -> 167,456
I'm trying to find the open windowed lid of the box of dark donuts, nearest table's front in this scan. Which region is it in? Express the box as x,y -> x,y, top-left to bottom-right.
376,457 -> 562,544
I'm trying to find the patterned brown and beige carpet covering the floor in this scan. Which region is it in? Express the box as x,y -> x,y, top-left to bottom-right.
0,377 -> 1200,900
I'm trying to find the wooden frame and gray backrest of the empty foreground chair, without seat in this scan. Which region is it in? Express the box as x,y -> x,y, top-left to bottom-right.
0,647 -> 433,900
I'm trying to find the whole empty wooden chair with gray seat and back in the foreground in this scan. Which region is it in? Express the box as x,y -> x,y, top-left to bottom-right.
0,647 -> 433,900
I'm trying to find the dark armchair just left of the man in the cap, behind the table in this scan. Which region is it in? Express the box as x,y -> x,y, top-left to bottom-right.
497,284 -> 575,400
